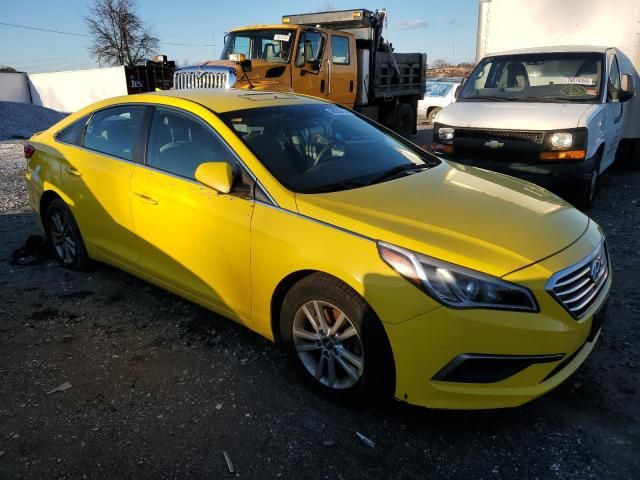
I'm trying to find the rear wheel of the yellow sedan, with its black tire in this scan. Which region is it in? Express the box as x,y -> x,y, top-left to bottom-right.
43,198 -> 91,271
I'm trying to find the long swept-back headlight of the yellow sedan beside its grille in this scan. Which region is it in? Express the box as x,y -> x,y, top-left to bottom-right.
378,242 -> 538,312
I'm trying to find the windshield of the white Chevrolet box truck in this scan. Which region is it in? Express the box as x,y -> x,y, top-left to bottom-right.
458,53 -> 603,103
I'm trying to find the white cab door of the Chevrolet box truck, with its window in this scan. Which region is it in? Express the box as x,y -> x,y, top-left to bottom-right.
600,52 -> 623,171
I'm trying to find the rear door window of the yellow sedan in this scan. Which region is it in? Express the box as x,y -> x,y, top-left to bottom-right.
83,105 -> 145,160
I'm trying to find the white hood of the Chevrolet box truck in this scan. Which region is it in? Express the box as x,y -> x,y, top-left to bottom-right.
438,101 -> 594,130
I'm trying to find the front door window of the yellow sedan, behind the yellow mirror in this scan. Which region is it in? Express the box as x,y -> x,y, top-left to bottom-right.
147,108 -> 236,178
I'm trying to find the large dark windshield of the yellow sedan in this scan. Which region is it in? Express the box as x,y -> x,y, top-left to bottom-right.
222,104 -> 439,193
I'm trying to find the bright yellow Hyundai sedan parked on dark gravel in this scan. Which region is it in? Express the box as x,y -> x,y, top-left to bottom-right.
25,90 -> 611,408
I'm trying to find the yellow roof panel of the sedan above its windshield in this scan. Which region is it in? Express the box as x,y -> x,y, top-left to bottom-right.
143,88 -> 327,113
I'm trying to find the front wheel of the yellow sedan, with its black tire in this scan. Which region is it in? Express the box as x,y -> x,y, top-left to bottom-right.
280,273 -> 395,402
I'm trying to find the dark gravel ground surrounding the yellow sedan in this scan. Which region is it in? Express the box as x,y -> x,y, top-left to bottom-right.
0,133 -> 640,479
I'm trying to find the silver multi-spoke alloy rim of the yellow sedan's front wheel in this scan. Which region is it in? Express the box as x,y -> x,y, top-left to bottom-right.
292,300 -> 364,389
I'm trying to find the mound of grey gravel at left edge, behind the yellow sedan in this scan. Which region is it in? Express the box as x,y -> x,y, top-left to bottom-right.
0,102 -> 67,141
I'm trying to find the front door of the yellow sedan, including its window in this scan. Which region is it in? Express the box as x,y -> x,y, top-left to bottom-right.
131,107 -> 253,321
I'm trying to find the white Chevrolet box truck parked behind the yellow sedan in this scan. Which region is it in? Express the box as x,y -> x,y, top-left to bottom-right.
433,0 -> 640,208
